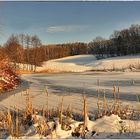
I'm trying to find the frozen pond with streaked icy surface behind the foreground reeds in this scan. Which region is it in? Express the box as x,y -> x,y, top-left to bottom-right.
0,72 -> 140,112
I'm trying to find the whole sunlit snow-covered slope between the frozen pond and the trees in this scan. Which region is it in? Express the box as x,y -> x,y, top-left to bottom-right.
37,55 -> 140,72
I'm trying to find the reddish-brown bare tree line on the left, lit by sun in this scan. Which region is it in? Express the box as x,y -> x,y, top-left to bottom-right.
0,34 -> 87,70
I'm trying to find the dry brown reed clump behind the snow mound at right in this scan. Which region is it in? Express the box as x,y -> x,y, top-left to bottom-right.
94,82 -> 139,120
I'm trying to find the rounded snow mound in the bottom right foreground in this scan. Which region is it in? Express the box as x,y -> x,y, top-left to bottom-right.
87,114 -> 140,138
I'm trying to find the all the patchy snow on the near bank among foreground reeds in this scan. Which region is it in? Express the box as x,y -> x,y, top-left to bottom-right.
3,114 -> 140,139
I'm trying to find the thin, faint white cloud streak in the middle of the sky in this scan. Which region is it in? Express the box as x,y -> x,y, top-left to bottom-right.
47,25 -> 88,33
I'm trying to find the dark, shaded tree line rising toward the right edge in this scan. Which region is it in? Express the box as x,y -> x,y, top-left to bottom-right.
88,24 -> 140,58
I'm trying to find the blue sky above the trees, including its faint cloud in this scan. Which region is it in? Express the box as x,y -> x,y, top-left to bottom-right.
0,1 -> 140,44
